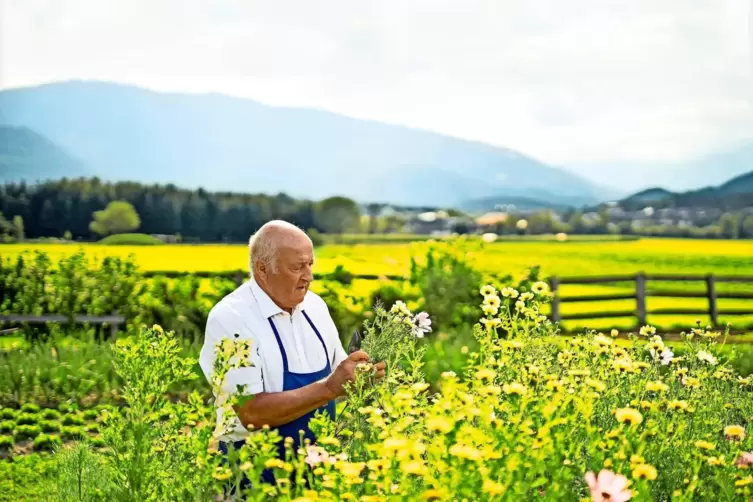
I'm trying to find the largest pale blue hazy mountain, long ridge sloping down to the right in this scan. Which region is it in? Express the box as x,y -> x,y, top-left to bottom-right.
0,82 -> 602,206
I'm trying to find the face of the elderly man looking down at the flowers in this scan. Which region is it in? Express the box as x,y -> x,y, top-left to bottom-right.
266,238 -> 314,309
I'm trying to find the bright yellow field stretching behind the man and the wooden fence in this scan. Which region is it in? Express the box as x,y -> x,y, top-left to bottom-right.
0,238 -> 753,328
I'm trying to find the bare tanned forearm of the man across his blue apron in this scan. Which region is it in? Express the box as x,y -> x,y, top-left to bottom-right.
235,381 -> 337,429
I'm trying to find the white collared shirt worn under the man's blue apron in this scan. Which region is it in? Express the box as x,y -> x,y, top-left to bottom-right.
199,279 -> 347,441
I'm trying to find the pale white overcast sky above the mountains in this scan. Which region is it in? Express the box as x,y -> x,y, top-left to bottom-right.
0,0 -> 753,188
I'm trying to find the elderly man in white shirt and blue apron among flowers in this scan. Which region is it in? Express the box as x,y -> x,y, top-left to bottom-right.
199,221 -> 384,481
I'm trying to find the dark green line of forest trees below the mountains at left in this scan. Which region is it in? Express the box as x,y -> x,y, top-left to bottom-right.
0,178 -> 360,242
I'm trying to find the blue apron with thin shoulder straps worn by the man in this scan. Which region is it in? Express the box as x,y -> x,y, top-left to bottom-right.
219,310 -> 335,489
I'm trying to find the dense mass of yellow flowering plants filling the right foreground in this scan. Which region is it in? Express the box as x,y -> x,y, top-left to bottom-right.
54,283 -> 753,502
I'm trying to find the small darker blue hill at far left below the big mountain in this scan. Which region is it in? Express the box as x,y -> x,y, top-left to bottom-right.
0,126 -> 88,182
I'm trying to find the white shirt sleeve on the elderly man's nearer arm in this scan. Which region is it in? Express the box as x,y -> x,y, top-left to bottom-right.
199,310 -> 264,396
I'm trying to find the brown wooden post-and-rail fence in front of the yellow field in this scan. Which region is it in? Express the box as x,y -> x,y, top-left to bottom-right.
549,273 -> 753,327
